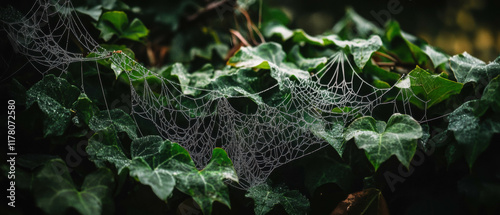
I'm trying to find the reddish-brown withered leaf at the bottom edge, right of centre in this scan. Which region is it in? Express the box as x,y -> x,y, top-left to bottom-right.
332,188 -> 389,215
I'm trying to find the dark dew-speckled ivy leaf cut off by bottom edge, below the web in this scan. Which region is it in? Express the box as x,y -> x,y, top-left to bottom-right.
245,184 -> 309,215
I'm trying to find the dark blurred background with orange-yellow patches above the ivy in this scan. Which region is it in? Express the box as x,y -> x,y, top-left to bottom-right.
266,0 -> 500,62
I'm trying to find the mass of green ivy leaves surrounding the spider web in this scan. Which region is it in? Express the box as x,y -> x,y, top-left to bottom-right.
2,0 -> 500,214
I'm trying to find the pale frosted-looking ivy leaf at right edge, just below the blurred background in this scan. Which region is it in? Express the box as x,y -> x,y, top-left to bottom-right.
450,52 -> 500,84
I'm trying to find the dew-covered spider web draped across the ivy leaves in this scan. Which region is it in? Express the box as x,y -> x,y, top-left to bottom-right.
1,0 -> 426,188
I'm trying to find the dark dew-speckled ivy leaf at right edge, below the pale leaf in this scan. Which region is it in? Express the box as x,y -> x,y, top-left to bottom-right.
448,100 -> 500,168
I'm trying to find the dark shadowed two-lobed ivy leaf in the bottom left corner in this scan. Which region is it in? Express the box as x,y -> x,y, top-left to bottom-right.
33,159 -> 114,215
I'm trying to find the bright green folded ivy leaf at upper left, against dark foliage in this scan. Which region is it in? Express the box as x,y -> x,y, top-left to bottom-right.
96,11 -> 149,42
